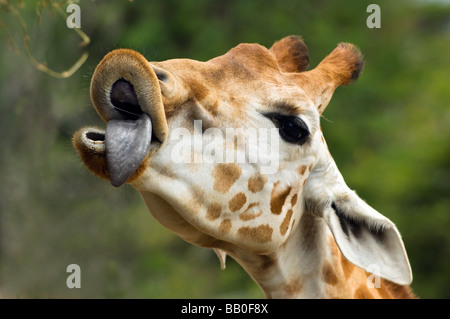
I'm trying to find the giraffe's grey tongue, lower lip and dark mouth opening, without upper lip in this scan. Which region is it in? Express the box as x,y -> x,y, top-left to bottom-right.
73,79 -> 161,187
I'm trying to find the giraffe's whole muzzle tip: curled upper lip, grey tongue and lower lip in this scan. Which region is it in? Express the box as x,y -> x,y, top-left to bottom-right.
73,49 -> 168,187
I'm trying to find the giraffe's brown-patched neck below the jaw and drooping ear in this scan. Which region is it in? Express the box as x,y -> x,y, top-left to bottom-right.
228,213 -> 413,299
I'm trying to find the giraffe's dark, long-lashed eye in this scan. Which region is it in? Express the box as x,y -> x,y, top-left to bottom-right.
266,113 -> 310,145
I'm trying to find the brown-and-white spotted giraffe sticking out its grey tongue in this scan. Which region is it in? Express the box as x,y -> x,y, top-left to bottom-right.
73,36 -> 414,298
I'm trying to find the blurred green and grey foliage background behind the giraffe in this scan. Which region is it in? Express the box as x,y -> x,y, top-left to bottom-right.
0,0 -> 450,298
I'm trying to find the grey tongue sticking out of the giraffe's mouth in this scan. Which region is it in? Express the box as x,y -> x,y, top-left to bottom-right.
105,113 -> 152,187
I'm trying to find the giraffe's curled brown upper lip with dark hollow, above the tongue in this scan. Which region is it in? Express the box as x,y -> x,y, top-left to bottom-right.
90,49 -> 168,142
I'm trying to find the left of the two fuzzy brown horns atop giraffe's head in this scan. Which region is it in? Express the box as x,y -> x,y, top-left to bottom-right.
270,35 -> 309,72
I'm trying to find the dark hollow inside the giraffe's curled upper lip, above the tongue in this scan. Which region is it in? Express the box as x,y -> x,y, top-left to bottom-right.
110,79 -> 142,120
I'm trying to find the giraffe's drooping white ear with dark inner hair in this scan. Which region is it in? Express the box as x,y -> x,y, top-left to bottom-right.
323,190 -> 412,285
